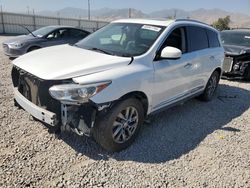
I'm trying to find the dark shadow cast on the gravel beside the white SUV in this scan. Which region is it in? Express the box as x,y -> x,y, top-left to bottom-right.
61,85 -> 250,163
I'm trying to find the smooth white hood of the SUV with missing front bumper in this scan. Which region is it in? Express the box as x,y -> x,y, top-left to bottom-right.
13,45 -> 131,80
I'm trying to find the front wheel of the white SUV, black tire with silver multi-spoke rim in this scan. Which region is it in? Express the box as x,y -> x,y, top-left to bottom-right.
93,98 -> 144,152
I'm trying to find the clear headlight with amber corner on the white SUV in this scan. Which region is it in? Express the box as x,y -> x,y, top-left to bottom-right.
49,81 -> 111,103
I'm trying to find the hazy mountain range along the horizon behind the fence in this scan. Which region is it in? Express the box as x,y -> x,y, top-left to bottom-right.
38,7 -> 250,28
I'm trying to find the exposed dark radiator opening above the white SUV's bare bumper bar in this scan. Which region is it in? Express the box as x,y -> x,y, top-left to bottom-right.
12,66 -> 68,117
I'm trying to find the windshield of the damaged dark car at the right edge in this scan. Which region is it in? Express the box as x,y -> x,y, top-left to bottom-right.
221,31 -> 250,47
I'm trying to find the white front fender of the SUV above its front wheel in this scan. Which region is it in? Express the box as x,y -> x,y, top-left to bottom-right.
73,63 -> 154,112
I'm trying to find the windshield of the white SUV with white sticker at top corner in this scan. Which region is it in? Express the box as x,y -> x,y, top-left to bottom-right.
76,23 -> 165,57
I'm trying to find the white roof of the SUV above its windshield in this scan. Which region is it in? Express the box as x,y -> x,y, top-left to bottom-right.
112,19 -> 175,27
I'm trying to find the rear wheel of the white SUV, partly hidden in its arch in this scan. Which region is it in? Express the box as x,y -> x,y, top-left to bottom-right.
198,71 -> 220,102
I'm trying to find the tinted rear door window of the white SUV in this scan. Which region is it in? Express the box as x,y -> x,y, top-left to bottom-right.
187,26 -> 208,52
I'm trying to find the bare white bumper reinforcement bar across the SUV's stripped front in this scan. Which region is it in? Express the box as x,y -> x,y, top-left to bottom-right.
13,87 -> 57,126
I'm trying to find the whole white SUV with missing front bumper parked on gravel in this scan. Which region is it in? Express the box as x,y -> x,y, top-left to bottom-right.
12,19 -> 224,151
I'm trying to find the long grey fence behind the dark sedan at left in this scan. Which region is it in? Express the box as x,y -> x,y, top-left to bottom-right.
0,12 -> 108,34
